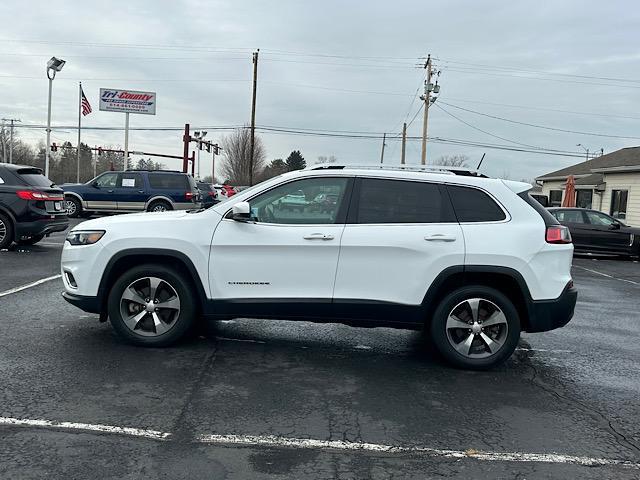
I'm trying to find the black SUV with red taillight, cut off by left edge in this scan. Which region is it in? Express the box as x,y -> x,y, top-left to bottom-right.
0,163 -> 69,248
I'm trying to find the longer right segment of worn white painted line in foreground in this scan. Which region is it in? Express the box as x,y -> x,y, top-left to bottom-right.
198,435 -> 640,469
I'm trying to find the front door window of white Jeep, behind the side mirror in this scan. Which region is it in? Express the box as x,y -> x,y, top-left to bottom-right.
249,177 -> 349,224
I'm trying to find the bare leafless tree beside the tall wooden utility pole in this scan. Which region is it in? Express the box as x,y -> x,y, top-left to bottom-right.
222,128 -> 266,185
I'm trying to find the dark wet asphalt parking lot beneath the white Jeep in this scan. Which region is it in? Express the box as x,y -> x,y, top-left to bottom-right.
0,223 -> 640,479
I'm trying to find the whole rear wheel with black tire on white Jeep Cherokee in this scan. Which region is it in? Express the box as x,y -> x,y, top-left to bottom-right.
430,285 -> 520,370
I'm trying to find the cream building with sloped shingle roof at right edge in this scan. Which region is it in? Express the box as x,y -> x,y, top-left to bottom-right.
536,147 -> 640,225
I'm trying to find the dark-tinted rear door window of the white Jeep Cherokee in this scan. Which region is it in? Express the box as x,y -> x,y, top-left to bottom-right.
356,178 -> 456,223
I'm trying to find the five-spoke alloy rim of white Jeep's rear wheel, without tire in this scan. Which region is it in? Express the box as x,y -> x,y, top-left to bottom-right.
446,298 -> 509,358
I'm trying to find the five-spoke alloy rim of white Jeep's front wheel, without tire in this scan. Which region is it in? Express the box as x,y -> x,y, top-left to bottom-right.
120,277 -> 180,337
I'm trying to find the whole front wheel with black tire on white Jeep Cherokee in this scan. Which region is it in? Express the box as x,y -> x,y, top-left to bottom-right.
108,264 -> 196,347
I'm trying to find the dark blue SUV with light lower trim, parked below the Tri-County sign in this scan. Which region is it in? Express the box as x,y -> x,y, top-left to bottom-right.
62,170 -> 200,217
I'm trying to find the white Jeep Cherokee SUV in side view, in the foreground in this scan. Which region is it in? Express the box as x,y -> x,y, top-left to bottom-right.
62,165 -> 577,369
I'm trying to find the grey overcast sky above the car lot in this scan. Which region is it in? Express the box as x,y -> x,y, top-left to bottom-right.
0,0 -> 640,179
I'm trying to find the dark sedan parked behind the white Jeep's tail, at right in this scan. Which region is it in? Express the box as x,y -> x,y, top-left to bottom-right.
549,207 -> 640,257
